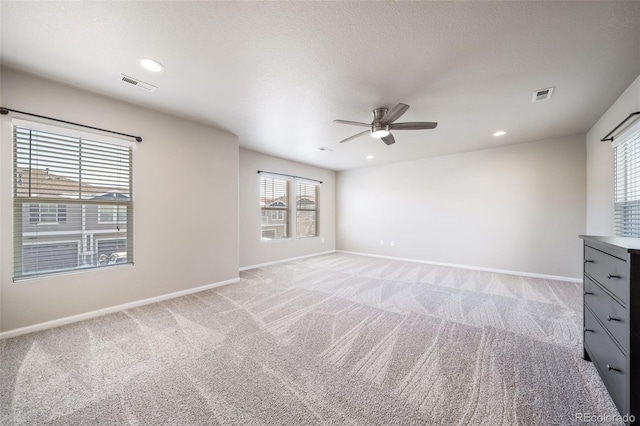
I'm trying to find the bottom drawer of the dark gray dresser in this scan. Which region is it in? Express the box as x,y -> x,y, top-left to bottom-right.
584,307 -> 629,414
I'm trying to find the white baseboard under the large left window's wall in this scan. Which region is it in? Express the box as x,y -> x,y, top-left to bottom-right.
0,278 -> 240,340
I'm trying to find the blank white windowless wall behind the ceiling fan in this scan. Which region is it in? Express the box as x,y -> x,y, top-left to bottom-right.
336,136 -> 586,278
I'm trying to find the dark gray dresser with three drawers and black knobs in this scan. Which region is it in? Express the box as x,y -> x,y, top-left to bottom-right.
580,235 -> 640,419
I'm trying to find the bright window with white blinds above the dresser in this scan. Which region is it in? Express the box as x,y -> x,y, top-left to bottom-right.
614,125 -> 640,237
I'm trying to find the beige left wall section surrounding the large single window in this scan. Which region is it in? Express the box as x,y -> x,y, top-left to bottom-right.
0,68 -> 238,331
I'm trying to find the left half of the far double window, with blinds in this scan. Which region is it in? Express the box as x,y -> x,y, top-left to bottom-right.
260,176 -> 289,241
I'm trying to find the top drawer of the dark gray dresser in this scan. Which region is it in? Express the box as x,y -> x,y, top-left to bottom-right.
584,245 -> 629,305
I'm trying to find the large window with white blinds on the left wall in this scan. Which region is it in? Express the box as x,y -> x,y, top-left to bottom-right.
13,122 -> 133,279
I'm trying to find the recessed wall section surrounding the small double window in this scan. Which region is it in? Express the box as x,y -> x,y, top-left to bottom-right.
240,149 -> 336,267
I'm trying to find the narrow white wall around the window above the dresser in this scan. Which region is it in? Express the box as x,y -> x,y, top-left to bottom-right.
587,72 -> 640,235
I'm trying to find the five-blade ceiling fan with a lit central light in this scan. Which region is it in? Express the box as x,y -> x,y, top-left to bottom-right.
333,104 -> 438,145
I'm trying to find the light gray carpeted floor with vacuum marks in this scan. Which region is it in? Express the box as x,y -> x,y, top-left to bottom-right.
0,253 -> 617,425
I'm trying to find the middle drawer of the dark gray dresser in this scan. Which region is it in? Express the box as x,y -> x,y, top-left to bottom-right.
584,276 -> 629,353
